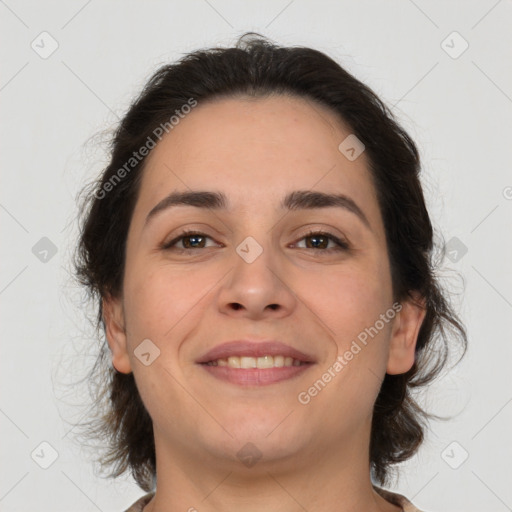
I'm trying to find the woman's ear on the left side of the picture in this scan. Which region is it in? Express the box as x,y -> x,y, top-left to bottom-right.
102,295 -> 132,373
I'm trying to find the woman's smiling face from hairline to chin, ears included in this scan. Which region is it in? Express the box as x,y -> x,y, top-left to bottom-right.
104,96 -> 422,472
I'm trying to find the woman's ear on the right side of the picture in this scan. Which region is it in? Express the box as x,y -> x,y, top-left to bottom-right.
386,292 -> 427,375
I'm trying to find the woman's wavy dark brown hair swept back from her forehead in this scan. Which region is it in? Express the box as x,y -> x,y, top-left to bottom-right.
75,33 -> 467,491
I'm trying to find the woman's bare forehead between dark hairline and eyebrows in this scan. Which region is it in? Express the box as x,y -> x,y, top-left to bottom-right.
136,95 -> 373,219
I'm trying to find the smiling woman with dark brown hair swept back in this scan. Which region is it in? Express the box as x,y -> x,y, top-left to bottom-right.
76,35 -> 466,512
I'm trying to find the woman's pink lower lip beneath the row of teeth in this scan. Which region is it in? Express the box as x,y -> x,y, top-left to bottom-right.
201,363 -> 313,386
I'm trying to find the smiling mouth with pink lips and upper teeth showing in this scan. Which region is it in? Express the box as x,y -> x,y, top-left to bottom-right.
196,341 -> 315,386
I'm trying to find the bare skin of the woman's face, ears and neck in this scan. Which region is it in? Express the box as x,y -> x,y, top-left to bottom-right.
104,96 -> 425,512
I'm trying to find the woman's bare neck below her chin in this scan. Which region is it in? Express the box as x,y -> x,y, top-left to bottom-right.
144,422 -> 400,512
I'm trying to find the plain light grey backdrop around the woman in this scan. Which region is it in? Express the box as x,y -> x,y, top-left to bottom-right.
0,0 -> 512,512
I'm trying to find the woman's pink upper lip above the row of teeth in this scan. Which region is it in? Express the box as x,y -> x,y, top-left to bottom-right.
196,340 -> 315,363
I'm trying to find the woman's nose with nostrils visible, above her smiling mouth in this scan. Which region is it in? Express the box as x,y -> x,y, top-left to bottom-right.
218,240 -> 297,320
